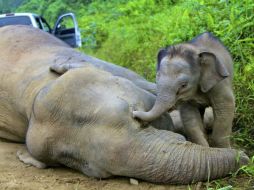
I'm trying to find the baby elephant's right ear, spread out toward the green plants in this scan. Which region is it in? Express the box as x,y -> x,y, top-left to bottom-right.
199,52 -> 229,92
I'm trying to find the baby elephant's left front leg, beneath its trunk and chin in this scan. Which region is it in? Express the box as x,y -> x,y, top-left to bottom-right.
180,103 -> 209,146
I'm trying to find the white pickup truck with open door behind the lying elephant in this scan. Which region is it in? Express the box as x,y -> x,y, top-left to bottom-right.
0,13 -> 81,47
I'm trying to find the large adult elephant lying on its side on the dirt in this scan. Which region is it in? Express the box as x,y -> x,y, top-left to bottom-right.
0,26 -> 248,184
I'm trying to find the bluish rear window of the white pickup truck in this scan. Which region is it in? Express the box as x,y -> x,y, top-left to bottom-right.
0,16 -> 32,27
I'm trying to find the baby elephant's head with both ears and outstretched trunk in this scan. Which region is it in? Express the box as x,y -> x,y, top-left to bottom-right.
133,43 -> 229,121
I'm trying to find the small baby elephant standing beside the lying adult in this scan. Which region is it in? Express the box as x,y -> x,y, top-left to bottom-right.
133,32 -> 235,147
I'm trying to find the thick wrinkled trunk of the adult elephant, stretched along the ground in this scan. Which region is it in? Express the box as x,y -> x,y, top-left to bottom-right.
110,127 -> 248,184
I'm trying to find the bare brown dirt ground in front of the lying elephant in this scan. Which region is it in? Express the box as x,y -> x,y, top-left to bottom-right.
0,142 -> 206,190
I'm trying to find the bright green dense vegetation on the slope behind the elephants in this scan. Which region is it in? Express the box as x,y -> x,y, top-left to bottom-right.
0,0 -> 254,187
